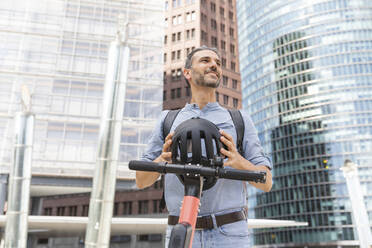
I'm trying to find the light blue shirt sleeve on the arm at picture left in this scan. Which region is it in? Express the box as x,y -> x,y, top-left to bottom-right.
140,110 -> 169,161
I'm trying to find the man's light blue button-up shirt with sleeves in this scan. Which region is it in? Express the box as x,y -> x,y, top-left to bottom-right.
141,102 -> 272,216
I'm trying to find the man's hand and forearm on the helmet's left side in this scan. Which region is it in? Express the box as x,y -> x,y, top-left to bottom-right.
136,133 -> 173,189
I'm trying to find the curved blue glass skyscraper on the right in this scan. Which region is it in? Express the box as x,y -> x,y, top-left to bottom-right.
237,0 -> 372,247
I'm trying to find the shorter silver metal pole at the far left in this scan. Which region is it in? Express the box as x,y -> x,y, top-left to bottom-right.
5,112 -> 34,248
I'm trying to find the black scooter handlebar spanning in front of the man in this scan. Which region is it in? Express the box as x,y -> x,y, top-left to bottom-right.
129,160 -> 266,183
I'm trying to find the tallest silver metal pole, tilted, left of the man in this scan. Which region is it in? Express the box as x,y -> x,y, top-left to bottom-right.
85,24 -> 130,248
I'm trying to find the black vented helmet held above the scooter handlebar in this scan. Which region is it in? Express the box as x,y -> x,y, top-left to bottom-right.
172,118 -> 223,190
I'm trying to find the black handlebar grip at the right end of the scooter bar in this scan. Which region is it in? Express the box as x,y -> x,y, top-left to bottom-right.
217,168 -> 266,183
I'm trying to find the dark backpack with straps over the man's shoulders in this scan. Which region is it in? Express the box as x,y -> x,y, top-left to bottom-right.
159,109 -> 244,210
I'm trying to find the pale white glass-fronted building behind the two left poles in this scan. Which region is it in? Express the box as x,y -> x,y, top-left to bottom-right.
0,0 -> 164,178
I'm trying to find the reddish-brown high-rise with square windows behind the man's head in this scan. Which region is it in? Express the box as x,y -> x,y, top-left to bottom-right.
163,0 -> 241,109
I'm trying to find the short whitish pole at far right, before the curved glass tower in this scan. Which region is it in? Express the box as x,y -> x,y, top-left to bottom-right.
341,160 -> 372,248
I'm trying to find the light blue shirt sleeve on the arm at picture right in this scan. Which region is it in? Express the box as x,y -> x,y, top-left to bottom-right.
241,111 -> 272,170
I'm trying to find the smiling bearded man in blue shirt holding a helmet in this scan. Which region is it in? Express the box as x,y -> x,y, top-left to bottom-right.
136,46 -> 272,248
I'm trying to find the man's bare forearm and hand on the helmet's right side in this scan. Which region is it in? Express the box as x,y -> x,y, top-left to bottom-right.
220,130 -> 273,192
